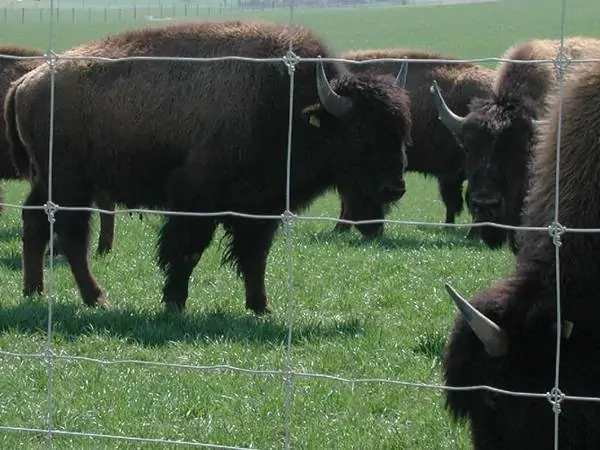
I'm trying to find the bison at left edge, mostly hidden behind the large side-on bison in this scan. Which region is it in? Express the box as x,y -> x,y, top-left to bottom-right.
0,46 -> 115,254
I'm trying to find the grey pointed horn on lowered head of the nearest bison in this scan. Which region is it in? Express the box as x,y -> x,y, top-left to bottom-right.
446,283 -> 508,357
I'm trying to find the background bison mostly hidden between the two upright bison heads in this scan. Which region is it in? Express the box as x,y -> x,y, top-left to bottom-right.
335,49 -> 494,237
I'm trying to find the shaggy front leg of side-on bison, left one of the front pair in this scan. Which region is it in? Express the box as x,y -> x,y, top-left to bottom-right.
158,216 -> 217,311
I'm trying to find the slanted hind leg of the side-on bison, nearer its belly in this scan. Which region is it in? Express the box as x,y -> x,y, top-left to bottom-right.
56,201 -> 109,307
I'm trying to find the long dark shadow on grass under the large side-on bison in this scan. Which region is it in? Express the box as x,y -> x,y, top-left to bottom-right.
0,297 -> 364,347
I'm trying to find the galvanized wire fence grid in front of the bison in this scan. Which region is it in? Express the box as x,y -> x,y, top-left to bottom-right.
0,52 -> 600,448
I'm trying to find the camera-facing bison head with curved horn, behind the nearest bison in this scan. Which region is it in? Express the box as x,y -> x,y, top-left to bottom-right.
431,81 -> 540,248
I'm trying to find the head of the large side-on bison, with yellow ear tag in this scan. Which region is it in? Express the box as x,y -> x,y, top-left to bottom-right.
303,61 -> 412,237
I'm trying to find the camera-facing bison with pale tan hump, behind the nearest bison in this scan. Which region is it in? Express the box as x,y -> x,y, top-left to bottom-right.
432,37 -> 600,253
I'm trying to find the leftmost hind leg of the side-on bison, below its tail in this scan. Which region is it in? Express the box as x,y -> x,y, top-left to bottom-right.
21,182 -> 50,297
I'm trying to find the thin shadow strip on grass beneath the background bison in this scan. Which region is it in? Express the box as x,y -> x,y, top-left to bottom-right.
305,226 -> 486,250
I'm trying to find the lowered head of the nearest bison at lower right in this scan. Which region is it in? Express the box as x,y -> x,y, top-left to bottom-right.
443,280 -> 600,450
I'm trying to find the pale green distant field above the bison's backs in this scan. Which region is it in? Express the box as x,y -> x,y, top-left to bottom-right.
0,0 -> 597,57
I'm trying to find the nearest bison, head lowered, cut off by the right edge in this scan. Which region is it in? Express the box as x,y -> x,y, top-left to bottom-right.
444,63 -> 600,450
